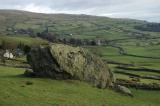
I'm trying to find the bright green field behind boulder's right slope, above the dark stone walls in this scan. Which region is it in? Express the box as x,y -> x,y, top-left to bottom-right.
85,46 -> 160,69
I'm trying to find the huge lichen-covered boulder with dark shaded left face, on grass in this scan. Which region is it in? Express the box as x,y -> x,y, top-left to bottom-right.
27,44 -> 114,88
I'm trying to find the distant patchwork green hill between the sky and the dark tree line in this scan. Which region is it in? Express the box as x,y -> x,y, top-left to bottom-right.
0,10 -> 159,39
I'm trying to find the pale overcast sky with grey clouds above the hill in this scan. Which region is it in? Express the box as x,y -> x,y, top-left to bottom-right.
0,0 -> 160,22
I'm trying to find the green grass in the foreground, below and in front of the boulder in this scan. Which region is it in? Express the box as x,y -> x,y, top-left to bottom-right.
0,66 -> 160,106
